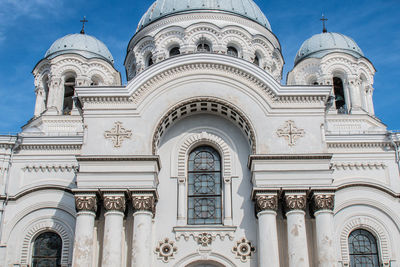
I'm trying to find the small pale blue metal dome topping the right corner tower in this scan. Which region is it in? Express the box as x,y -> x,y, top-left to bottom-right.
294,32 -> 364,65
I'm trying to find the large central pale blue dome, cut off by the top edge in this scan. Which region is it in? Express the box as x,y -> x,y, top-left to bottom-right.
138,0 -> 271,30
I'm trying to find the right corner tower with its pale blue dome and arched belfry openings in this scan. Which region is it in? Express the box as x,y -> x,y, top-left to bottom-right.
287,30 -> 375,115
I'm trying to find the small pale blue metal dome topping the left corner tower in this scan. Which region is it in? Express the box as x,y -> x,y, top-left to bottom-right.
45,33 -> 114,64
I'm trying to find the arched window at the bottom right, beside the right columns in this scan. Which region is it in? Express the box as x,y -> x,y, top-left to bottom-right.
349,229 -> 380,267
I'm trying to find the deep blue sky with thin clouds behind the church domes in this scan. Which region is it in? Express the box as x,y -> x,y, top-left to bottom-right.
0,0 -> 400,134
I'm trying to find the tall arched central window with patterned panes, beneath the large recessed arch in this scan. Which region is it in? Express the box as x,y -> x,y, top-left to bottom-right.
188,146 -> 222,224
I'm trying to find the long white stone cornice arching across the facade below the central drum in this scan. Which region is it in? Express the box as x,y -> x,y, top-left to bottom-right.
77,54 -> 330,105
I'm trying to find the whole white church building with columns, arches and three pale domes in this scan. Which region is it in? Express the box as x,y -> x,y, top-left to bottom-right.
0,0 -> 400,267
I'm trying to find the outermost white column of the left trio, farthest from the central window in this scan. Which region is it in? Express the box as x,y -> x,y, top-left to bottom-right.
72,194 -> 97,267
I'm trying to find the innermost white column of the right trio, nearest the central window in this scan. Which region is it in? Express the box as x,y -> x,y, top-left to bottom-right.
255,193 -> 280,267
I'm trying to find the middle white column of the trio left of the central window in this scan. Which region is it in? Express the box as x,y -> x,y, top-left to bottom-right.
101,193 -> 125,267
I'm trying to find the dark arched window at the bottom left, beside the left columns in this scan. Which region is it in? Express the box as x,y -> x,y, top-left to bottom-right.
32,232 -> 62,267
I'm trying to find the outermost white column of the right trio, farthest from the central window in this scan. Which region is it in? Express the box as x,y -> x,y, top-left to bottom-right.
313,193 -> 337,267
